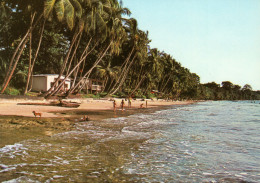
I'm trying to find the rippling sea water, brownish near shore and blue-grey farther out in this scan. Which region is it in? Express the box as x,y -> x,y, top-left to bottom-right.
0,101 -> 260,183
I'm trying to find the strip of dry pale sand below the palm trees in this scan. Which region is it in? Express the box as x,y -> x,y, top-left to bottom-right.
0,99 -> 193,118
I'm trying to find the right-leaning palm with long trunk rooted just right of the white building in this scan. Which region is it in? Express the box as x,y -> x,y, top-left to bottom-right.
64,0 -> 130,95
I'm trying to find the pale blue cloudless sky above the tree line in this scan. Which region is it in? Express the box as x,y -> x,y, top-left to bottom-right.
123,0 -> 260,90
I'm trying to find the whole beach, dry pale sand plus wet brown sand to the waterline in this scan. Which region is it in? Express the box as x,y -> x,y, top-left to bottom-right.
0,99 -> 196,148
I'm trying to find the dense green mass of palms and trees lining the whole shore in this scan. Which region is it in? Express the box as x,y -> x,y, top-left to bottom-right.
0,0 -> 260,100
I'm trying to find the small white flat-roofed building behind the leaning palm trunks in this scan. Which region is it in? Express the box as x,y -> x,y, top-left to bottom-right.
32,74 -> 71,92
